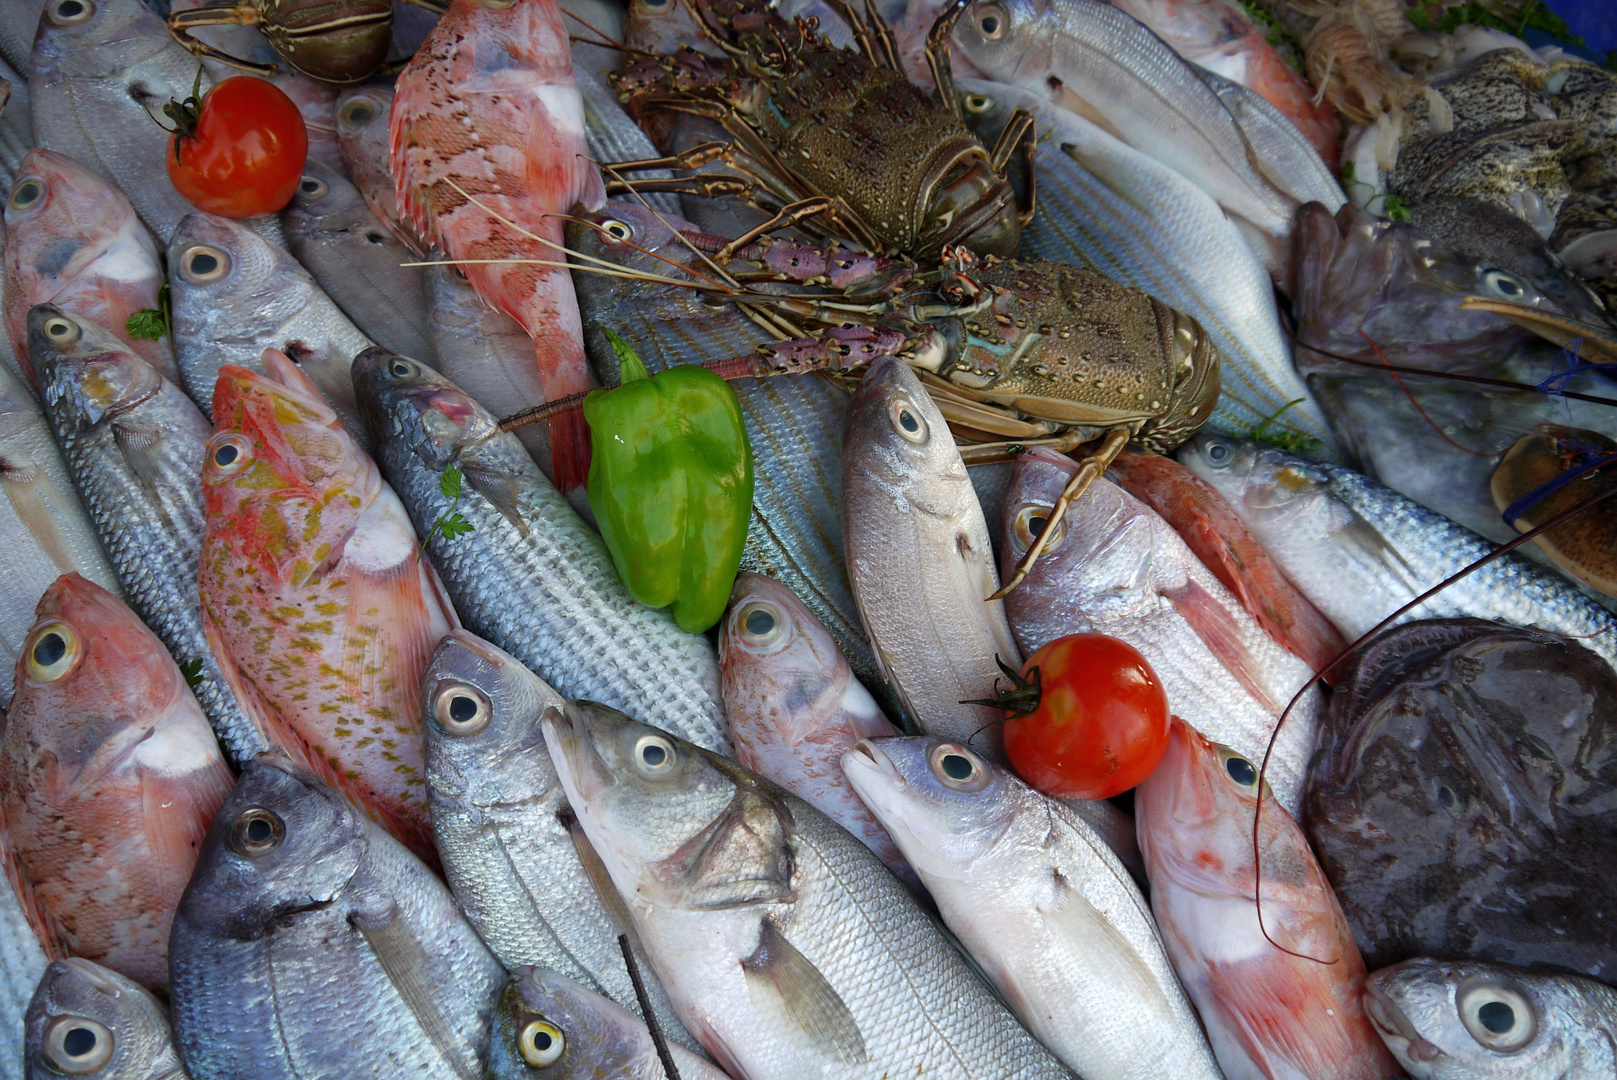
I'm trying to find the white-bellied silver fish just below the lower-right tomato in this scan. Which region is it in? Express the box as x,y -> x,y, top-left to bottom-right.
842,737 -> 1222,1080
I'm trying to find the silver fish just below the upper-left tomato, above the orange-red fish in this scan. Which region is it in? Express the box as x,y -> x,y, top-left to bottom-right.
168,213 -> 370,441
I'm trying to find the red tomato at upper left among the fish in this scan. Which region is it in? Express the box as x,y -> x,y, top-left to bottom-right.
165,74 -> 309,218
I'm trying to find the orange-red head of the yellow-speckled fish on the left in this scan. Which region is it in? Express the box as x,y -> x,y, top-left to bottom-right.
202,349 -> 382,585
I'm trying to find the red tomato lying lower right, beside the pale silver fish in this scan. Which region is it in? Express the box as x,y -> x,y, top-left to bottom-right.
1004,634 -> 1169,799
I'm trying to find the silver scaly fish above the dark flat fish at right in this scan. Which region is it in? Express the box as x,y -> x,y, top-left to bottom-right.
1179,435 -> 1617,664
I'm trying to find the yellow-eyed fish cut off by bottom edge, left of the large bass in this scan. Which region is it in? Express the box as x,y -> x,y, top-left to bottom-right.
488,967 -> 729,1080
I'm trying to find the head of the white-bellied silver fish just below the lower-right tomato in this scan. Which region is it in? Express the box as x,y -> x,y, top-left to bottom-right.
842,737 -> 1025,880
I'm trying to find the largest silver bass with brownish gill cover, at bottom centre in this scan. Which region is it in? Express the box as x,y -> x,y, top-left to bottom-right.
540,702 -> 1070,1080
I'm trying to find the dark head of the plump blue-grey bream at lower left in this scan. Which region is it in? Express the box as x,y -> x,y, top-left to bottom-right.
175,753 -> 375,941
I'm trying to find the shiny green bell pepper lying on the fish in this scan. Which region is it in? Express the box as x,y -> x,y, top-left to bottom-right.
584,331 -> 752,634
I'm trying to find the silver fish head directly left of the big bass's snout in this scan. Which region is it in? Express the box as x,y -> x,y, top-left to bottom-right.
422,631 -> 561,807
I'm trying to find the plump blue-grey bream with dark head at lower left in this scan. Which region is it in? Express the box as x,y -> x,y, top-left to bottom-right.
168,753 -> 505,1080
